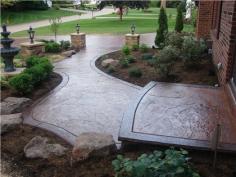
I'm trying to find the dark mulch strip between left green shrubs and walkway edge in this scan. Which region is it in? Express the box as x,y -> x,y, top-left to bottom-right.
1,73 -> 62,101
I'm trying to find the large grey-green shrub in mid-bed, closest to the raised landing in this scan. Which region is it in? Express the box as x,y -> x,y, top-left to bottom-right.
155,46 -> 178,78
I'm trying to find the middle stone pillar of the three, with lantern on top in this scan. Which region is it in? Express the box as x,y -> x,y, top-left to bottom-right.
70,33 -> 86,50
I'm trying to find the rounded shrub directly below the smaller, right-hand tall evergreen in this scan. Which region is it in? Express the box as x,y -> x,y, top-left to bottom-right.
166,32 -> 184,49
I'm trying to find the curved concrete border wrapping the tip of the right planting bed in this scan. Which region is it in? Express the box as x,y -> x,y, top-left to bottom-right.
90,50 -> 142,90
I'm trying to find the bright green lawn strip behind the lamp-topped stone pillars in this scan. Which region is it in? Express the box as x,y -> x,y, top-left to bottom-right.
13,8 -> 193,37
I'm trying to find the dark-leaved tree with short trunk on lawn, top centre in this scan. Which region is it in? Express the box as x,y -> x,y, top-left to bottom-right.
98,0 -> 150,20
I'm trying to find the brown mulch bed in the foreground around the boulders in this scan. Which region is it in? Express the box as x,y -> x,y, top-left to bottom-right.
1,125 -> 236,177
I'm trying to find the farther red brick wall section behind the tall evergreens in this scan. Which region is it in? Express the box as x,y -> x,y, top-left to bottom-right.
196,0 -> 214,39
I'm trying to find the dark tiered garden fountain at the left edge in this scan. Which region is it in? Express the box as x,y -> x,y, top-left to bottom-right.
1,24 -> 20,72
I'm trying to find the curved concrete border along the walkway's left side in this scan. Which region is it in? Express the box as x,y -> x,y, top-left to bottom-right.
23,70 -> 77,145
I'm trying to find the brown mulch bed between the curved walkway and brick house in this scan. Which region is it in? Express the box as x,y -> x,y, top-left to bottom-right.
96,49 -> 218,86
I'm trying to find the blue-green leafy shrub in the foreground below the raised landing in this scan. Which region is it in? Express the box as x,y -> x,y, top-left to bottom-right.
112,149 -> 200,177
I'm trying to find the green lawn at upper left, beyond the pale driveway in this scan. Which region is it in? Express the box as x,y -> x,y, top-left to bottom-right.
1,9 -> 78,25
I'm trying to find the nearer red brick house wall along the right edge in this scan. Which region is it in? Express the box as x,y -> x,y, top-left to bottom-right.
211,1 -> 236,85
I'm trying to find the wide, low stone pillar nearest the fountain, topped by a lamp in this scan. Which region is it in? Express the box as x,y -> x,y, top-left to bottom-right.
20,42 -> 45,57
